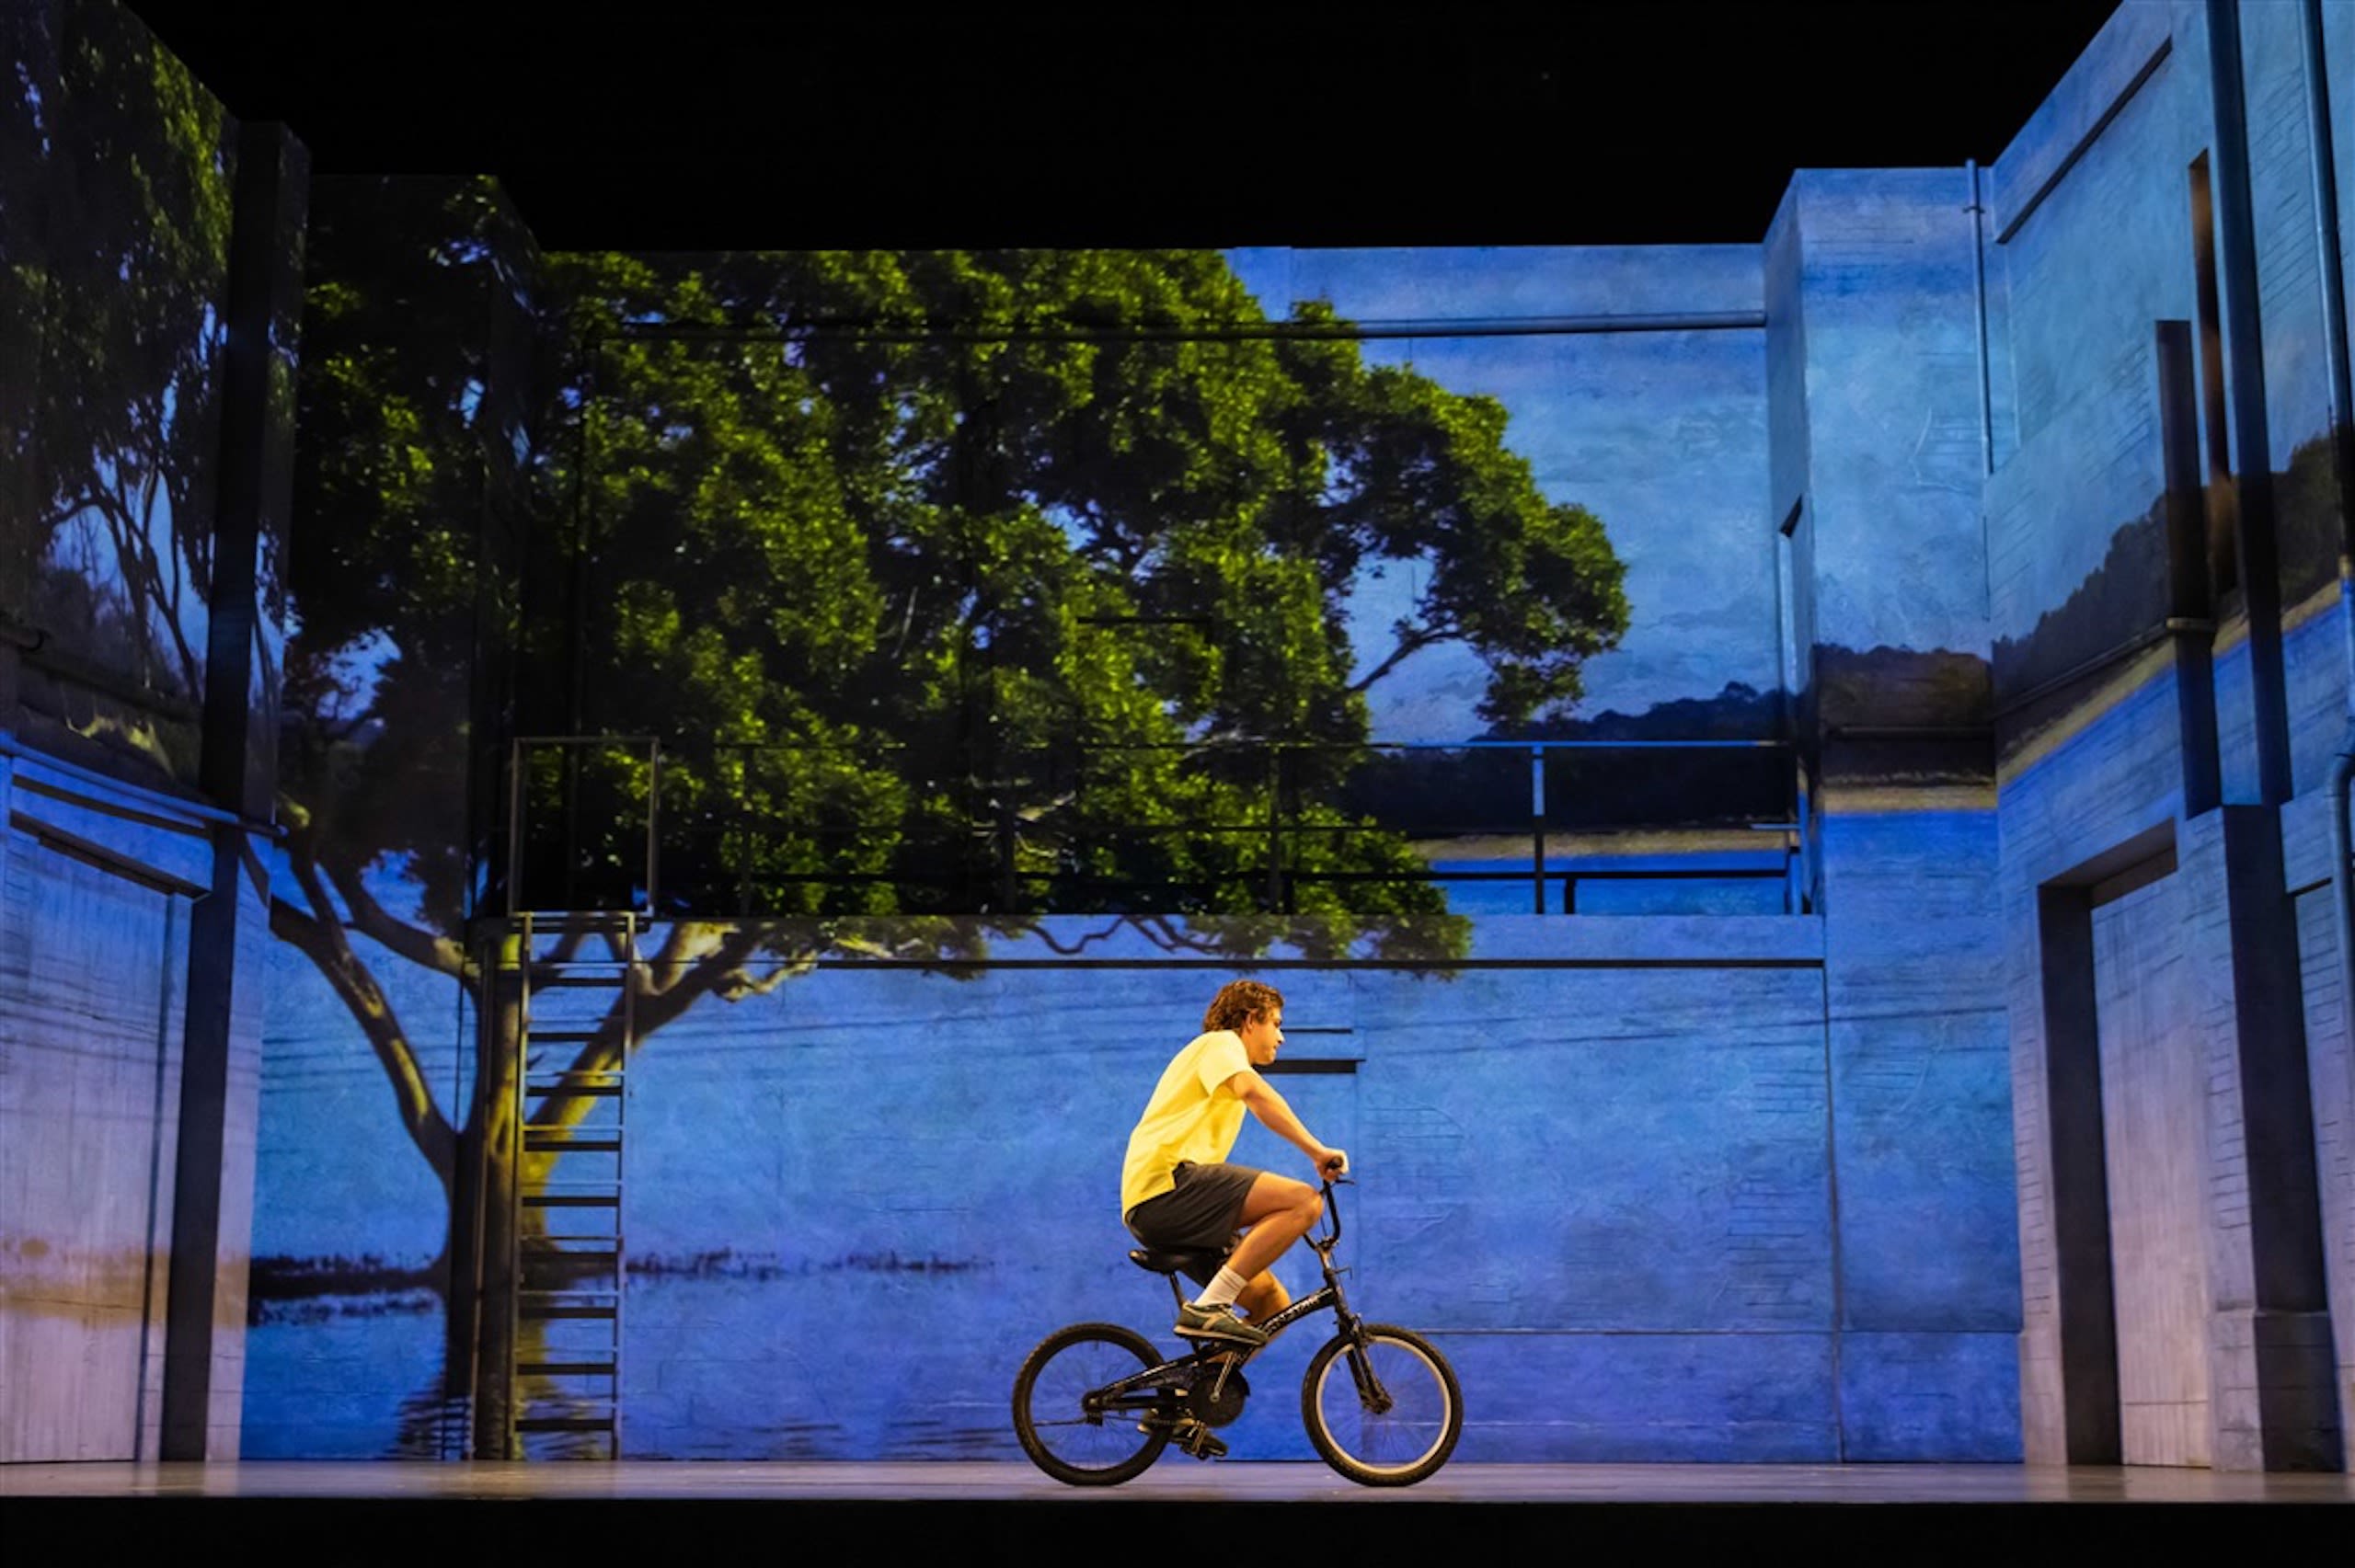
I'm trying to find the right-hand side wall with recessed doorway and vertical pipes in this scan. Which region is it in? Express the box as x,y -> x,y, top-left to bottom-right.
1985,5 -> 2355,1467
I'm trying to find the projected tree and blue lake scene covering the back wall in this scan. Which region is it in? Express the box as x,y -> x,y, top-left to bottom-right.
245,213 -> 2009,1458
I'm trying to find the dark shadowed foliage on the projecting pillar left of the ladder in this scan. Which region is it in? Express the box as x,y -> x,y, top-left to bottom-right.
270,179 -> 537,1185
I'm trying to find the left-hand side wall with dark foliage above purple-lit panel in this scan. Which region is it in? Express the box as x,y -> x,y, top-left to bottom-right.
0,0 -> 304,1459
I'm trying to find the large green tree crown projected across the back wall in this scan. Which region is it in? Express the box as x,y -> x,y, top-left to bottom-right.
276,216 -> 1627,1196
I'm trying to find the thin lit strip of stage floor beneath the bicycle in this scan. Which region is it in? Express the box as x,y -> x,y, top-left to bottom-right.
0,1455 -> 2355,1505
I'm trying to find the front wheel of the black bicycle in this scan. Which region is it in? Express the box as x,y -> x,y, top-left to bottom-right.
1300,1323 -> 1465,1485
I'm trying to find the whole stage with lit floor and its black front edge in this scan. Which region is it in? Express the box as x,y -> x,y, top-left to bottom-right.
0,1455 -> 2355,1568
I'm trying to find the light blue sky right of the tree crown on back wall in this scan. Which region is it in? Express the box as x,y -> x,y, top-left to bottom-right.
1229,245 -> 1775,741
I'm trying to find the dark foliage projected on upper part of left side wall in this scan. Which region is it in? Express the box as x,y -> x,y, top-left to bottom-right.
0,3 -> 233,774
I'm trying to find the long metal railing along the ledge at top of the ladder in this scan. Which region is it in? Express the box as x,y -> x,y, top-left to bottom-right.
509,737 -> 1811,916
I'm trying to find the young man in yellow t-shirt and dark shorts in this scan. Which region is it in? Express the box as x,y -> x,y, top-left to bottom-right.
1121,979 -> 1350,1345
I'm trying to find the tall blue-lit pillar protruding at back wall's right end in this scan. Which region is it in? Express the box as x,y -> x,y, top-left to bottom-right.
1762,155 -> 2018,1459
